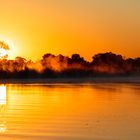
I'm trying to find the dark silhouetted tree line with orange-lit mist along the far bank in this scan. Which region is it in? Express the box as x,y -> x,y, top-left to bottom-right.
0,52 -> 140,78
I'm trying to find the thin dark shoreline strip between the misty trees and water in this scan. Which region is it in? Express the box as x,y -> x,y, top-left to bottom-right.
0,76 -> 140,84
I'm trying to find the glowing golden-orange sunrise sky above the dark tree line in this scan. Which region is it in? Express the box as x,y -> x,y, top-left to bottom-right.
0,0 -> 140,60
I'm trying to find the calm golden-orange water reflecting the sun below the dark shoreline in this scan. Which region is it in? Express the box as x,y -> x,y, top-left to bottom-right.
0,83 -> 140,140
